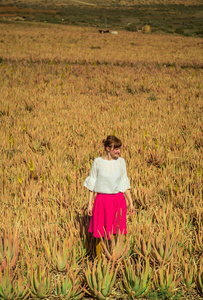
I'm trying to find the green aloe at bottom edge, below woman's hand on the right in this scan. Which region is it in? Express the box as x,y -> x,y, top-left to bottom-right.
122,259 -> 151,299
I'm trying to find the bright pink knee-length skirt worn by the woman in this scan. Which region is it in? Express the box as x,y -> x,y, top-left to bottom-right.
89,193 -> 127,239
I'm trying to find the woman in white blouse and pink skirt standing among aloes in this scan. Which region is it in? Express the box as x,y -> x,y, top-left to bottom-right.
84,135 -> 135,259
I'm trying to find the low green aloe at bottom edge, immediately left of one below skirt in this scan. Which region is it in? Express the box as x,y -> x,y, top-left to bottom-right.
55,271 -> 84,300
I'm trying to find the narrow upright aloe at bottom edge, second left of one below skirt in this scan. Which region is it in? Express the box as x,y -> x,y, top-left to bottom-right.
30,264 -> 51,299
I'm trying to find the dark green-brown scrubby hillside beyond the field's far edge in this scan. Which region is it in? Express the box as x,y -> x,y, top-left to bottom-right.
0,0 -> 203,37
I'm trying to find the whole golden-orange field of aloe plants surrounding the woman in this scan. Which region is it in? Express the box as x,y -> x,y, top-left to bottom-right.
0,23 -> 203,299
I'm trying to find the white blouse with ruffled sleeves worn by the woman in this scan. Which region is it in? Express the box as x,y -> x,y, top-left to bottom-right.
84,157 -> 130,194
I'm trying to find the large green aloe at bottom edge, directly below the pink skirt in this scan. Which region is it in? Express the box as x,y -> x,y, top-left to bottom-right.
85,257 -> 118,300
